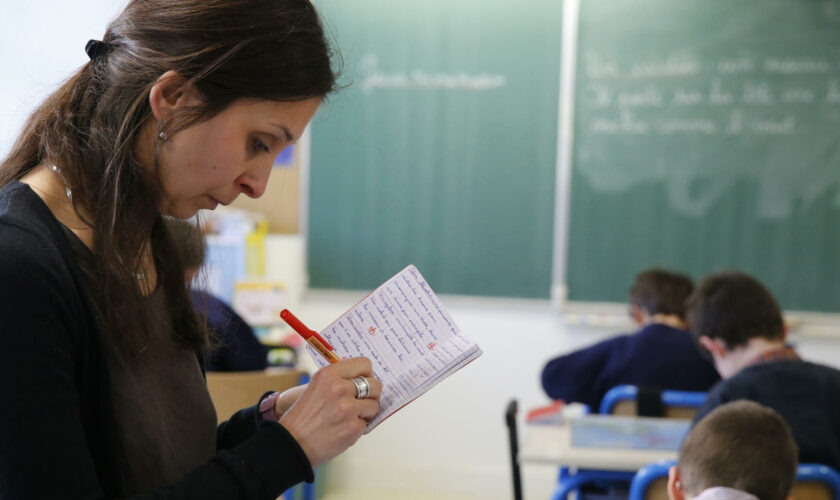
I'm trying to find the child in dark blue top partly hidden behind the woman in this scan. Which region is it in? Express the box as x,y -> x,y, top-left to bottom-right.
166,218 -> 268,372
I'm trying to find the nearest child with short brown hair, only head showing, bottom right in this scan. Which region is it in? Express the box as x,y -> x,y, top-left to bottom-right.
668,401 -> 797,500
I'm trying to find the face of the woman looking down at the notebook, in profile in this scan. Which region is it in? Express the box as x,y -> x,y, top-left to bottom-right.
159,98 -> 321,219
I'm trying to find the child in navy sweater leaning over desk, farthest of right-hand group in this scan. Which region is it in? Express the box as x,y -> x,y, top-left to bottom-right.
542,269 -> 720,411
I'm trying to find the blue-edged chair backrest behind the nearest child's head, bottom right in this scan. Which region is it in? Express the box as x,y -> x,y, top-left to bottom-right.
629,460 -> 840,500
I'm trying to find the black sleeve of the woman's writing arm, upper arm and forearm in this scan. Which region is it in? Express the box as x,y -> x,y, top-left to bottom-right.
0,222 -> 312,500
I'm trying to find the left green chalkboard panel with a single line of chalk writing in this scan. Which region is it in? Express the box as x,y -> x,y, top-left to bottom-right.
308,0 -> 562,297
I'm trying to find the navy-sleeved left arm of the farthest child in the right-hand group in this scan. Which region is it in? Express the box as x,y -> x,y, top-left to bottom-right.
542,338 -> 621,412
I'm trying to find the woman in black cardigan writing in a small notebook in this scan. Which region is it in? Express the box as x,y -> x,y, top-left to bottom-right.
0,0 -> 381,498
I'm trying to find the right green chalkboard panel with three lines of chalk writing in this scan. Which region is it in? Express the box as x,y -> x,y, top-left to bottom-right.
566,0 -> 840,312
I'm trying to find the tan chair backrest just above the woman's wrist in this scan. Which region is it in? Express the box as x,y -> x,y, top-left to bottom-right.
207,369 -> 309,422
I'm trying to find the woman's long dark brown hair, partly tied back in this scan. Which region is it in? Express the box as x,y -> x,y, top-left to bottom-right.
0,0 -> 336,353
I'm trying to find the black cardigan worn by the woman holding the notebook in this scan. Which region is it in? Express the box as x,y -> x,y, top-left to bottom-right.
0,182 -> 313,499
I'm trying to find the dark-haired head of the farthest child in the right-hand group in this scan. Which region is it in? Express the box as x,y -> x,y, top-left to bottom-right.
630,269 -> 694,320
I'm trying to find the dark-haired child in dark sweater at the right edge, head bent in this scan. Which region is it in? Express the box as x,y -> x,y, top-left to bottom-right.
688,272 -> 840,469
